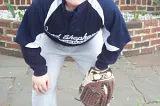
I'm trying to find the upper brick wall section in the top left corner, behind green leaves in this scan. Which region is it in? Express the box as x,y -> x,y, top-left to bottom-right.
0,0 -> 32,10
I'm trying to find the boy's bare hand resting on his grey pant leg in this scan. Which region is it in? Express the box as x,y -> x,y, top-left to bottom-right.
32,73 -> 49,94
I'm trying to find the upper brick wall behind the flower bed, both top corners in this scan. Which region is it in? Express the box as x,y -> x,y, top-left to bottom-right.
0,0 -> 160,12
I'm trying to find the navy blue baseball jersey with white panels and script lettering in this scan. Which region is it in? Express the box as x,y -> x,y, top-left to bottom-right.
16,0 -> 131,76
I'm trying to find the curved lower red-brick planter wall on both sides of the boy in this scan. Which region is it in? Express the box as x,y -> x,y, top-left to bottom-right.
0,19 -> 160,57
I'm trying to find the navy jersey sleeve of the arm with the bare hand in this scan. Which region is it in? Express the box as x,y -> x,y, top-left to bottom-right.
15,0 -> 47,76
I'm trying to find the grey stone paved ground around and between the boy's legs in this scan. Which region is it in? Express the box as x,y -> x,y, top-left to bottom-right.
0,53 -> 160,106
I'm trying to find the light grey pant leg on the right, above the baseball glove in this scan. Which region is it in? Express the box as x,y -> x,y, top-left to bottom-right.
71,33 -> 104,75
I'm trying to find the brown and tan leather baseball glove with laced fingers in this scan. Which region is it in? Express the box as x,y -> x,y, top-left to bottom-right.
79,67 -> 115,106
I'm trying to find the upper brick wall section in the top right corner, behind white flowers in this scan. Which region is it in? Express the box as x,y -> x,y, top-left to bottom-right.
115,0 -> 160,12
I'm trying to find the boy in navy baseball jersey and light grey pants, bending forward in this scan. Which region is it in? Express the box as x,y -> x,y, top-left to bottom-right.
16,0 -> 131,106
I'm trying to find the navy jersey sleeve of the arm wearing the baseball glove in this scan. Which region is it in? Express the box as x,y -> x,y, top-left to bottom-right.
96,0 -> 131,69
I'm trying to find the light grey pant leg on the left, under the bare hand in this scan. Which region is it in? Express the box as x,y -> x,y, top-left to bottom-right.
32,36 -> 65,106
